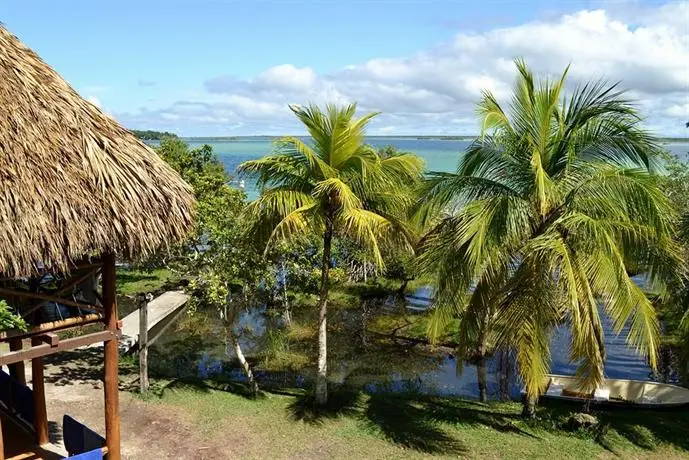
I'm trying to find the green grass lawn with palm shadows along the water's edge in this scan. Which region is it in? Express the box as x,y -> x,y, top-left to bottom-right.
137,382 -> 689,459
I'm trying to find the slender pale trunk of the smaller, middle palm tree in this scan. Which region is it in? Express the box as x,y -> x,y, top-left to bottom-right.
316,219 -> 333,405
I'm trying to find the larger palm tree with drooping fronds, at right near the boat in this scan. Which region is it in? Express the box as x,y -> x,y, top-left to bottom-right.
421,60 -> 679,413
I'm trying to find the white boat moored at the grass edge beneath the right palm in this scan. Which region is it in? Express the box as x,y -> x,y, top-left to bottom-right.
541,374 -> 689,409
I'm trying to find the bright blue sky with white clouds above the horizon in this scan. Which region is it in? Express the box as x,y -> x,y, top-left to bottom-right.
0,0 -> 689,135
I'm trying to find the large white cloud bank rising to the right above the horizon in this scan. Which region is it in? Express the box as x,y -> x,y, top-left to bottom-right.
114,1 -> 689,135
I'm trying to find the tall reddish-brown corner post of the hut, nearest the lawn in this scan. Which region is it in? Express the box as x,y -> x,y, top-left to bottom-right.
103,252 -> 120,460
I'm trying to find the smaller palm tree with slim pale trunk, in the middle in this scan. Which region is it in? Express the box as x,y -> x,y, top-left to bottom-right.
240,104 -> 423,404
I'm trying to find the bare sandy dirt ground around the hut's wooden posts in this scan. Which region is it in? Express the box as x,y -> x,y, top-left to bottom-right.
38,349 -> 228,460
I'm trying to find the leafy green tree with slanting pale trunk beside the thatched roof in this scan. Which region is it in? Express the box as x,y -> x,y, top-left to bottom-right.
153,139 -> 269,393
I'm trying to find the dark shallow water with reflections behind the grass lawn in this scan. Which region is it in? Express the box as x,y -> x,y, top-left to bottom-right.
150,287 -> 680,398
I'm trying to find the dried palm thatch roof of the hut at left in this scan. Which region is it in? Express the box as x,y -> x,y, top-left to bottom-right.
0,26 -> 194,277
